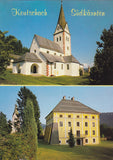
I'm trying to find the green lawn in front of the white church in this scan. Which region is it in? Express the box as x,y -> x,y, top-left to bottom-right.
0,70 -> 89,85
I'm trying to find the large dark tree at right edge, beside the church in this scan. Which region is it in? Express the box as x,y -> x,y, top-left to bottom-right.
90,25 -> 113,84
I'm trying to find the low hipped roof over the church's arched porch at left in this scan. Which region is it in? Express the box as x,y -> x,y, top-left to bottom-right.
14,52 -> 42,63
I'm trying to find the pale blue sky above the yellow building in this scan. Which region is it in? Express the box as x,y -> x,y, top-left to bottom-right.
0,86 -> 113,123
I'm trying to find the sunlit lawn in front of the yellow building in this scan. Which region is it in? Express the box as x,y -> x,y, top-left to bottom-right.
37,141 -> 113,160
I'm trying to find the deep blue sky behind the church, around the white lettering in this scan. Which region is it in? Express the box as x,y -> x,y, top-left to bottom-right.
0,0 -> 113,65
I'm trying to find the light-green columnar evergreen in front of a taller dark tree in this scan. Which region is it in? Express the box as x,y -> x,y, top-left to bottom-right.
22,99 -> 37,160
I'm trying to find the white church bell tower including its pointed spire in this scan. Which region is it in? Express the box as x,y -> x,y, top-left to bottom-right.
53,1 -> 71,56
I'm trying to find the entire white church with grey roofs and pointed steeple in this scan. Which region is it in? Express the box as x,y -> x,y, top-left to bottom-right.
13,4 -> 83,76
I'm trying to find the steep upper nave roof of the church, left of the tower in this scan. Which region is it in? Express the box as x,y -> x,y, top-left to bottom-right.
35,35 -> 63,53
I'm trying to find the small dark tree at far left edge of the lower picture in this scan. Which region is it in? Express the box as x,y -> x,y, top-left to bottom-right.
0,112 -> 8,136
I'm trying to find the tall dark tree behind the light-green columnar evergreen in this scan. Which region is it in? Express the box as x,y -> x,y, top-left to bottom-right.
17,87 -> 42,137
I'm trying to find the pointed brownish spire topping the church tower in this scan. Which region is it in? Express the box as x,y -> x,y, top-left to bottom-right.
57,0 -> 66,30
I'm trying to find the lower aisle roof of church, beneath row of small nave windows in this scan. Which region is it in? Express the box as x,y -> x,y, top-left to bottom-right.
41,52 -> 64,62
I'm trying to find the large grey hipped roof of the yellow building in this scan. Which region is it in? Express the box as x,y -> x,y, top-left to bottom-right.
46,99 -> 100,117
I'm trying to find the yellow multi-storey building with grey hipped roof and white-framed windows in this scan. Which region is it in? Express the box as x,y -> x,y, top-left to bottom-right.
44,96 -> 100,145
